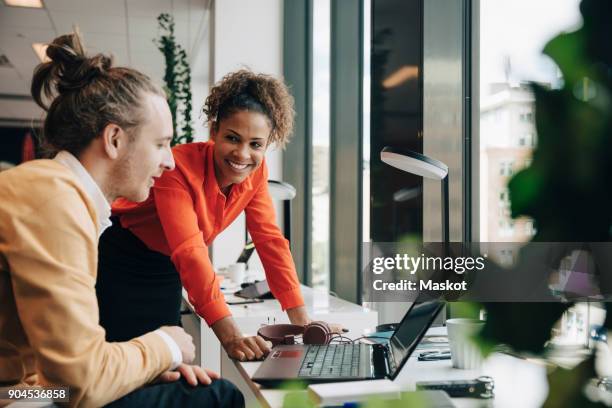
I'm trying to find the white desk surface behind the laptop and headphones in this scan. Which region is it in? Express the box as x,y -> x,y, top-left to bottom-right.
183,286 -> 378,377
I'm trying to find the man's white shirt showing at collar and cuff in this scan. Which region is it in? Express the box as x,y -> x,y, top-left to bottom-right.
53,150 -> 183,370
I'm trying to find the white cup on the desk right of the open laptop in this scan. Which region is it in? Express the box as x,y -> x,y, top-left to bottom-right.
446,319 -> 484,369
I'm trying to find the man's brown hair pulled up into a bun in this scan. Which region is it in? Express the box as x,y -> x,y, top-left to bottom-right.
31,29 -> 165,155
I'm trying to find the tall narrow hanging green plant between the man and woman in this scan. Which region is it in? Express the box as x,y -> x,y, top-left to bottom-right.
154,13 -> 193,146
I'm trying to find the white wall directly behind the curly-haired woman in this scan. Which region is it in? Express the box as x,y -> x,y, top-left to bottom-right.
211,0 -> 283,268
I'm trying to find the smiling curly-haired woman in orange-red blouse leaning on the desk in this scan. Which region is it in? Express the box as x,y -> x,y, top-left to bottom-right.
97,70 -> 320,360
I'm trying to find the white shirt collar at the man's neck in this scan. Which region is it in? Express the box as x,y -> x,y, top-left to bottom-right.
53,150 -> 112,238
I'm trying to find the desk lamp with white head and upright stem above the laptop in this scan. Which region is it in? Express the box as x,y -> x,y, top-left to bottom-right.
380,146 -> 449,244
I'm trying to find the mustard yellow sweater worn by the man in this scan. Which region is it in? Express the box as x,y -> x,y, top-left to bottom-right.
0,160 -> 172,407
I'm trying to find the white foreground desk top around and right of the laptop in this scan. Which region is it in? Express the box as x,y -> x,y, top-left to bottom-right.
221,328 -> 548,408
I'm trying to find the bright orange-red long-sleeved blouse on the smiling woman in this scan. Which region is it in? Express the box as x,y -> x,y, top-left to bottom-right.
113,141 -> 304,325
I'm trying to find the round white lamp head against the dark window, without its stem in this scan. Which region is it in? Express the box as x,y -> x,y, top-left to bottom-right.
380,147 -> 448,180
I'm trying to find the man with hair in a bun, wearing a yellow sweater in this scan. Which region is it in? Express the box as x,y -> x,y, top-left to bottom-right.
0,33 -> 244,407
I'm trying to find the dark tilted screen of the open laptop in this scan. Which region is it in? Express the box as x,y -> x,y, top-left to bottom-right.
389,301 -> 444,379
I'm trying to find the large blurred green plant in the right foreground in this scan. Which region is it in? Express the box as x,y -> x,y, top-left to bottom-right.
482,0 -> 612,407
